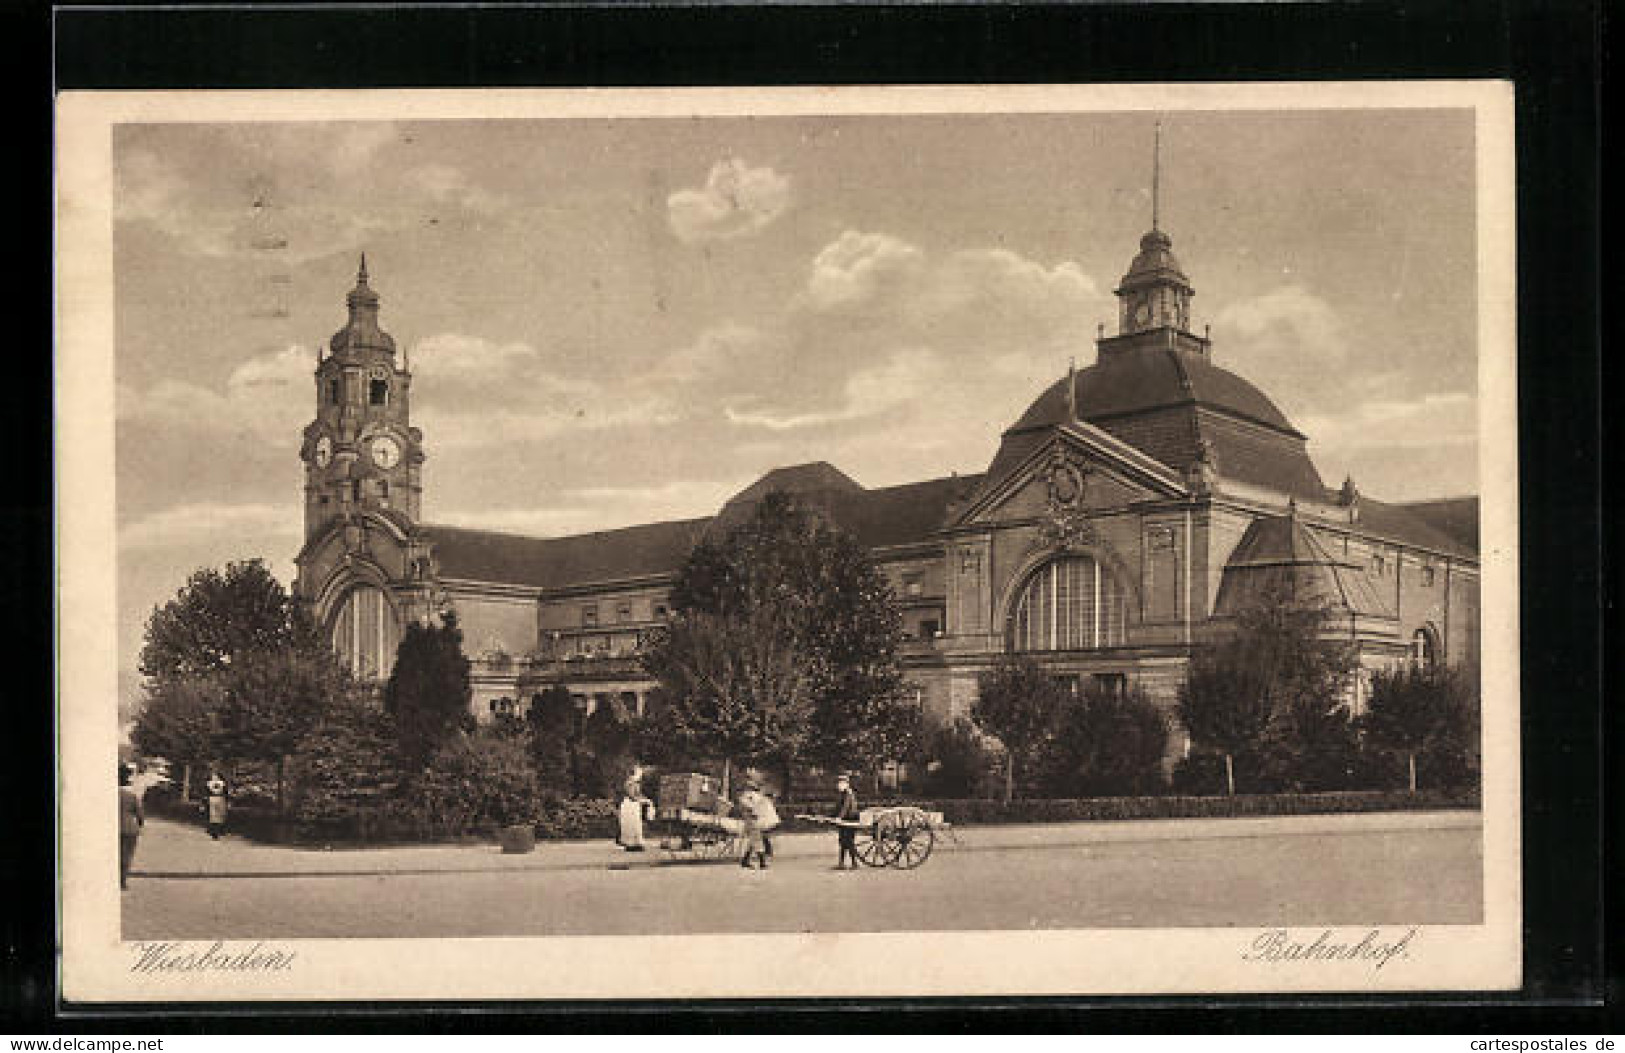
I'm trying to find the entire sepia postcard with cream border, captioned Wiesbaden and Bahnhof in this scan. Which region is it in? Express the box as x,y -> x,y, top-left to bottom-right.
57,83 -> 1519,1001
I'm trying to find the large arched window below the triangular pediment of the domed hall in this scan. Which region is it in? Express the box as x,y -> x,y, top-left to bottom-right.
1009,556 -> 1128,652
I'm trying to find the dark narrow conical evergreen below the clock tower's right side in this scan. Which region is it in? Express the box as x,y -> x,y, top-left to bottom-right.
384,611 -> 473,769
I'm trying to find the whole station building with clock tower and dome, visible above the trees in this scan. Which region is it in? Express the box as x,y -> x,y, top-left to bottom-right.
296,229 -> 1479,760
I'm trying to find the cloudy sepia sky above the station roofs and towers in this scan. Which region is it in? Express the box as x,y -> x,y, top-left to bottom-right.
112,111 -> 1479,711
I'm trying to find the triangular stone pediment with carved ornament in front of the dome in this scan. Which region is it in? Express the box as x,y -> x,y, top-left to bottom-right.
954,421 -> 1188,527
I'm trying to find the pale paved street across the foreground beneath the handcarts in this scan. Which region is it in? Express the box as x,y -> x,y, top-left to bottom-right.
124,813 -> 1482,939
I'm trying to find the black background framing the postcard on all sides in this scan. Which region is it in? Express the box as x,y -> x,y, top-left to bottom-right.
15,0 -> 1620,1042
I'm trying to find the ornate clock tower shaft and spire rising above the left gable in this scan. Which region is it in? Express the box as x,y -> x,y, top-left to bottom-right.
299,255 -> 424,540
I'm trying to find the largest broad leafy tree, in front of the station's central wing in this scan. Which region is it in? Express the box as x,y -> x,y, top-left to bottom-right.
648,492 -> 917,786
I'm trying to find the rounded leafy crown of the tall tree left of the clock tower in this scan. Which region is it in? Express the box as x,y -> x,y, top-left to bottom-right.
140,559 -> 320,686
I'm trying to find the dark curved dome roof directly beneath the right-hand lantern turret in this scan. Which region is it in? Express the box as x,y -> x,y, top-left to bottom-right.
1006,346 -> 1303,439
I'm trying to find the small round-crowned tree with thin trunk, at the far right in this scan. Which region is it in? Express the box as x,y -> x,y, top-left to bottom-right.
1360,665 -> 1477,793
